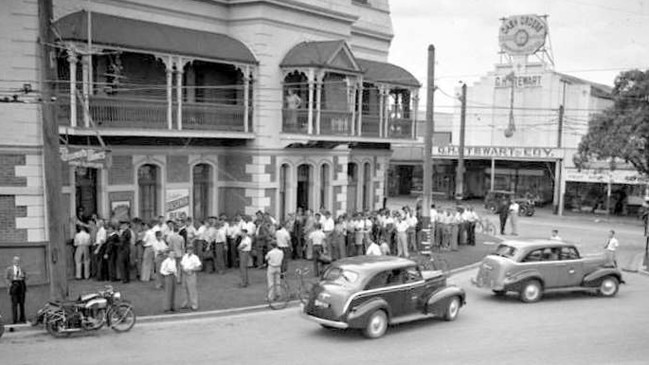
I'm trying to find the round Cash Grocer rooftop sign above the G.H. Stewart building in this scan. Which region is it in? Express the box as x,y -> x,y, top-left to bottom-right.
498,15 -> 548,56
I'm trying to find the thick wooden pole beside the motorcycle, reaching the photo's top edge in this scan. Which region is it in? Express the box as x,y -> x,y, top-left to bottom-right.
38,0 -> 68,300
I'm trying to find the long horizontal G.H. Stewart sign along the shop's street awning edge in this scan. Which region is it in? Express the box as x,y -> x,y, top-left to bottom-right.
433,146 -> 564,160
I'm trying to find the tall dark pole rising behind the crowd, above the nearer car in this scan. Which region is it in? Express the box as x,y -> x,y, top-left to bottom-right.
421,44 -> 435,228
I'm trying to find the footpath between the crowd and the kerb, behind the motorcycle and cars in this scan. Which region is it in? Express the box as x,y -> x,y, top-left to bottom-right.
0,234 -> 500,335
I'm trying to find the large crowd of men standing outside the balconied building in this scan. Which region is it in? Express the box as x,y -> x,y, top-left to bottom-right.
73,205 -> 479,288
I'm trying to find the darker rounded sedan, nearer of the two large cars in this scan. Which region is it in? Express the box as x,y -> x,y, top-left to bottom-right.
302,256 -> 466,338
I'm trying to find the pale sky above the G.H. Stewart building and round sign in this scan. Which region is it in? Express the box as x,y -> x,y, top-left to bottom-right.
389,0 -> 649,113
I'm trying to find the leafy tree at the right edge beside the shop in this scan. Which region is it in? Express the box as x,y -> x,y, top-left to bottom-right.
575,70 -> 649,175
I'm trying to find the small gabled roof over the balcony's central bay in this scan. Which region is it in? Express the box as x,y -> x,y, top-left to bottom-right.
280,40 -> 362,74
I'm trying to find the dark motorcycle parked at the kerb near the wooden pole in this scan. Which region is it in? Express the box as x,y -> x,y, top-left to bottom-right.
32,285 -> 136,337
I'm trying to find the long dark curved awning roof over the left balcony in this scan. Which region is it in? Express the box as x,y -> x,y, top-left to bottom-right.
54,10 -> 257,64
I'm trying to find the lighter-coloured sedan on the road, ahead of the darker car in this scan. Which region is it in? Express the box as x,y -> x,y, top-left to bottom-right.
472,239 -> 624,303
